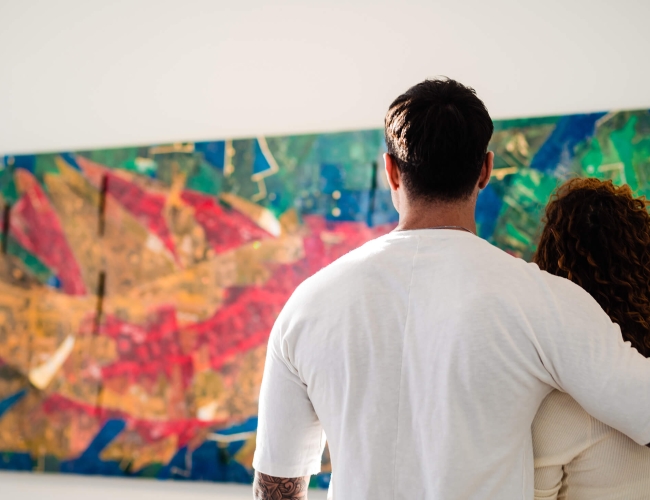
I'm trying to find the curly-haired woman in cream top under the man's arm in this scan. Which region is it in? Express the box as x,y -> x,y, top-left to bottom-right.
533,179 -> 650,500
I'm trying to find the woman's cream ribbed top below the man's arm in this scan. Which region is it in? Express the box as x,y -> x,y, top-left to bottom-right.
533,391 -> 650,500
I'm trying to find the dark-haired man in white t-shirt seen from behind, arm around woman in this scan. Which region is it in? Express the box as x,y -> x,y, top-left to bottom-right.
253,80 -> 650,500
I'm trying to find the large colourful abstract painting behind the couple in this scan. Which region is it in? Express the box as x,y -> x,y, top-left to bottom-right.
0,111 -> 650,486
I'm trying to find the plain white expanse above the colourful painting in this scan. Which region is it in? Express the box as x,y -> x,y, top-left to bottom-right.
0,0 -> 650,153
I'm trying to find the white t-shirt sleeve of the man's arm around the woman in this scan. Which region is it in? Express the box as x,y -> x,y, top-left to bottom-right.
537,275 -> 650,444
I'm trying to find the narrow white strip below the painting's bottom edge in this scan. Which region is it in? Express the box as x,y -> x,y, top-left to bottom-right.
0,472 -> 327,500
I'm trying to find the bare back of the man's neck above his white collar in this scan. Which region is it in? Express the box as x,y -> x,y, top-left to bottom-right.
390,200 -> 476,233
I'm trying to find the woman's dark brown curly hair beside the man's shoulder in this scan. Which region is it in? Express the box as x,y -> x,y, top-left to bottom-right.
533,179 -> 650,357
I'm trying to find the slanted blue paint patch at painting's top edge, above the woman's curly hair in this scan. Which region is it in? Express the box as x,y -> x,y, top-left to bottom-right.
530,113 -> 607,173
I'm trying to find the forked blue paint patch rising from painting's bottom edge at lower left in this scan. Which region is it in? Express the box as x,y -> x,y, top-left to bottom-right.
61,419 -> 126,476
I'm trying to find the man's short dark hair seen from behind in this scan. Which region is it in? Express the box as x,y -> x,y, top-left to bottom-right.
385,78 -> 494,201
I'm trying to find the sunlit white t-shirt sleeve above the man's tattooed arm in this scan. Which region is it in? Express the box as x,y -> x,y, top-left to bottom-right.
253,316 -> 325,478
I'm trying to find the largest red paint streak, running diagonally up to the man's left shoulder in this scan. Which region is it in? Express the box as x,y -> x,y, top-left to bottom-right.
100,217 -> 390,387
